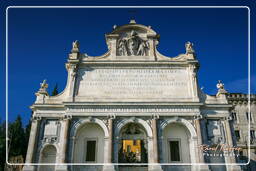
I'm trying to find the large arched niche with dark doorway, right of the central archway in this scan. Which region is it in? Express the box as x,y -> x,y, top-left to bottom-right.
163,123 -> 191,163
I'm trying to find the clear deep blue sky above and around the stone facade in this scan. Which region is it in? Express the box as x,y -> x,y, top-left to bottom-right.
0,1 -> 256,123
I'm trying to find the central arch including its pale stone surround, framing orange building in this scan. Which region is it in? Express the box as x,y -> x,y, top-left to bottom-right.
114,117 -> 153,166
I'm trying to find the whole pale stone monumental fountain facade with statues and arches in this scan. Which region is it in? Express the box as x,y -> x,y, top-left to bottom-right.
24,20 -> 248,171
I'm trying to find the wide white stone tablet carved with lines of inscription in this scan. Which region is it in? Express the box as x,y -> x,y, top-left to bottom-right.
77,68 -> 191,99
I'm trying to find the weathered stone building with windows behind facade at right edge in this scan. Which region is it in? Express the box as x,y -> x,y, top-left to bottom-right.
227,93 -> 256,170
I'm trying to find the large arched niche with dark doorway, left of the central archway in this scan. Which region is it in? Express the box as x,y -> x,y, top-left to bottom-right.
73,123 -> 105,163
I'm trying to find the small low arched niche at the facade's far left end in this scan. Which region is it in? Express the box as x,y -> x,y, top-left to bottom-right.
39,145 -> 57,171
